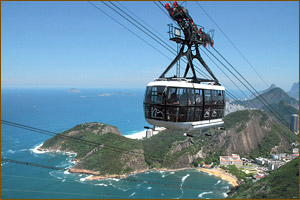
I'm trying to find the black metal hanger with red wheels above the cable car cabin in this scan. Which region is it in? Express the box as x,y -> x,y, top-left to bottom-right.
159,1 -> 220,85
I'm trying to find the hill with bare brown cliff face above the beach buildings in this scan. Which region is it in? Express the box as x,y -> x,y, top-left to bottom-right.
198,110 -> 299,162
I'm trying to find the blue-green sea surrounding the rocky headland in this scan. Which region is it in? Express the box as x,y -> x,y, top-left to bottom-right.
1,89 -> 231,199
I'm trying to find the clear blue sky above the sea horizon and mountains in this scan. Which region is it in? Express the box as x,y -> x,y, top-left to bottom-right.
1,1 -> 299,91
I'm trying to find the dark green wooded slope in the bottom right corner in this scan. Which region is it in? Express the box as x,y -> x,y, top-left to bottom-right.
227,157 -> 299,199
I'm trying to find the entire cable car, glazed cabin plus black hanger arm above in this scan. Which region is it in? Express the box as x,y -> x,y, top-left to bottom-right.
144,2 -> 225,131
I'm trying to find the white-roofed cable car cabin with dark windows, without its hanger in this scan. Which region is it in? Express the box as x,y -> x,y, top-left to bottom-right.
144,79 -> 225,131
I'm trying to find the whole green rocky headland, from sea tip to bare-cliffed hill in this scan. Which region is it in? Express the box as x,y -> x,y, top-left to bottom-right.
41,110 -> 298,176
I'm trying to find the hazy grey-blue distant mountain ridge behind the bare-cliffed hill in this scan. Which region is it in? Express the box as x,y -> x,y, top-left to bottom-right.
236,87 -> 299,109
